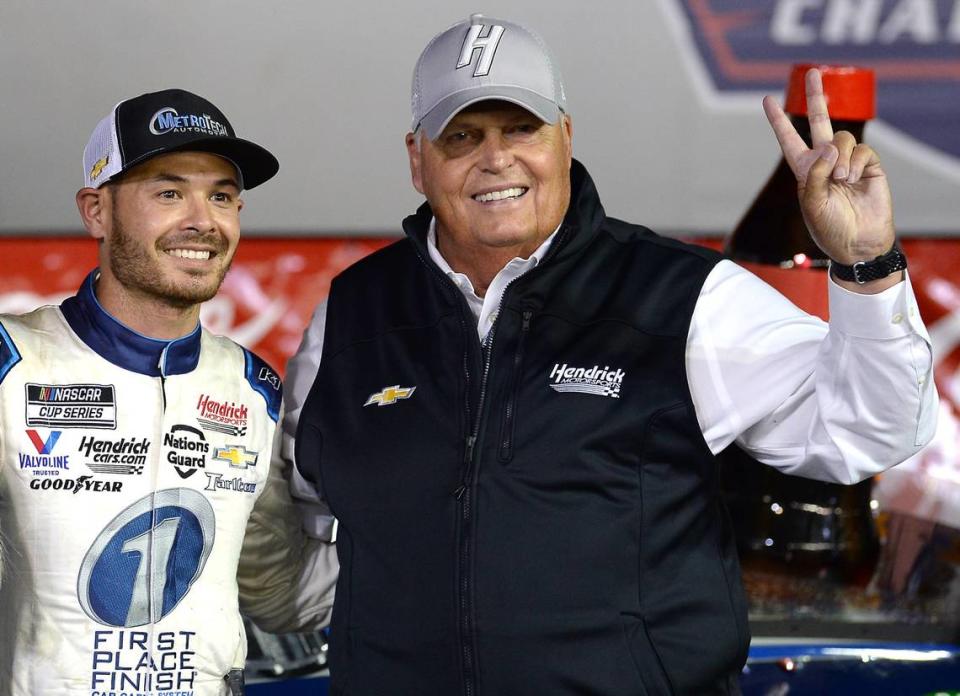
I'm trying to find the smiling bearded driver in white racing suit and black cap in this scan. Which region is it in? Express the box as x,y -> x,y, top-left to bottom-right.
0,90 -> 332,696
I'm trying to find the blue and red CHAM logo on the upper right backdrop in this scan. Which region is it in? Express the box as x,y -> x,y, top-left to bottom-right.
661,0 -> 960,167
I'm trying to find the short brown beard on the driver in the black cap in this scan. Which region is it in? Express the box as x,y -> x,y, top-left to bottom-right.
107,200 -> 233,309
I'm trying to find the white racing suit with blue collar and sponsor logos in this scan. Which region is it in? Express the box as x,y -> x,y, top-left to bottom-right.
0,272 -> 332,696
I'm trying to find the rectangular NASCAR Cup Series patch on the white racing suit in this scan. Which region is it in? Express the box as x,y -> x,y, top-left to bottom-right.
26,383 -> 117,430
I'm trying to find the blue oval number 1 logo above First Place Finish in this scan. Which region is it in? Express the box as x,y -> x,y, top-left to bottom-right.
77,488 -> 216,628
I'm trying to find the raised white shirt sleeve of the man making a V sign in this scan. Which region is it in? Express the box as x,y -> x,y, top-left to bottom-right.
686,260 -> 938,483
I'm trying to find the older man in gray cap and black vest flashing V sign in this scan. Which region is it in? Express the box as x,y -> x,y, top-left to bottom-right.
286,15 -> 936,696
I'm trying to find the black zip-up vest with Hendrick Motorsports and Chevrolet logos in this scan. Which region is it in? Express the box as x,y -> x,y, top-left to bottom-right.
297,162 -> 749,696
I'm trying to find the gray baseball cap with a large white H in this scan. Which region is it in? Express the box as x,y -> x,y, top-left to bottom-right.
410,14 -> 567,140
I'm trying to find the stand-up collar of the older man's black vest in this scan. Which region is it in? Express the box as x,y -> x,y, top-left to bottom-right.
403,159 -> 606,262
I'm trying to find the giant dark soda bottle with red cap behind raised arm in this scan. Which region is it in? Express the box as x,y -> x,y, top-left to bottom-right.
720,65 -> 878,600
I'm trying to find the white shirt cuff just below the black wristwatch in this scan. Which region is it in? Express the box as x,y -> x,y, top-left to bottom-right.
827,271 -> 927,339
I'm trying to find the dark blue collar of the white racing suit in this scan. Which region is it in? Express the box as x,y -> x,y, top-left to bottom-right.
60,268 -> 200,377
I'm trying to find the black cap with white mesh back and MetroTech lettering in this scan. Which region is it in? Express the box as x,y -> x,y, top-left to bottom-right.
83,89 -> 280,189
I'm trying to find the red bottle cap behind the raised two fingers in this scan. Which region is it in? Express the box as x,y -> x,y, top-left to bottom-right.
783,63 -> 877,121
